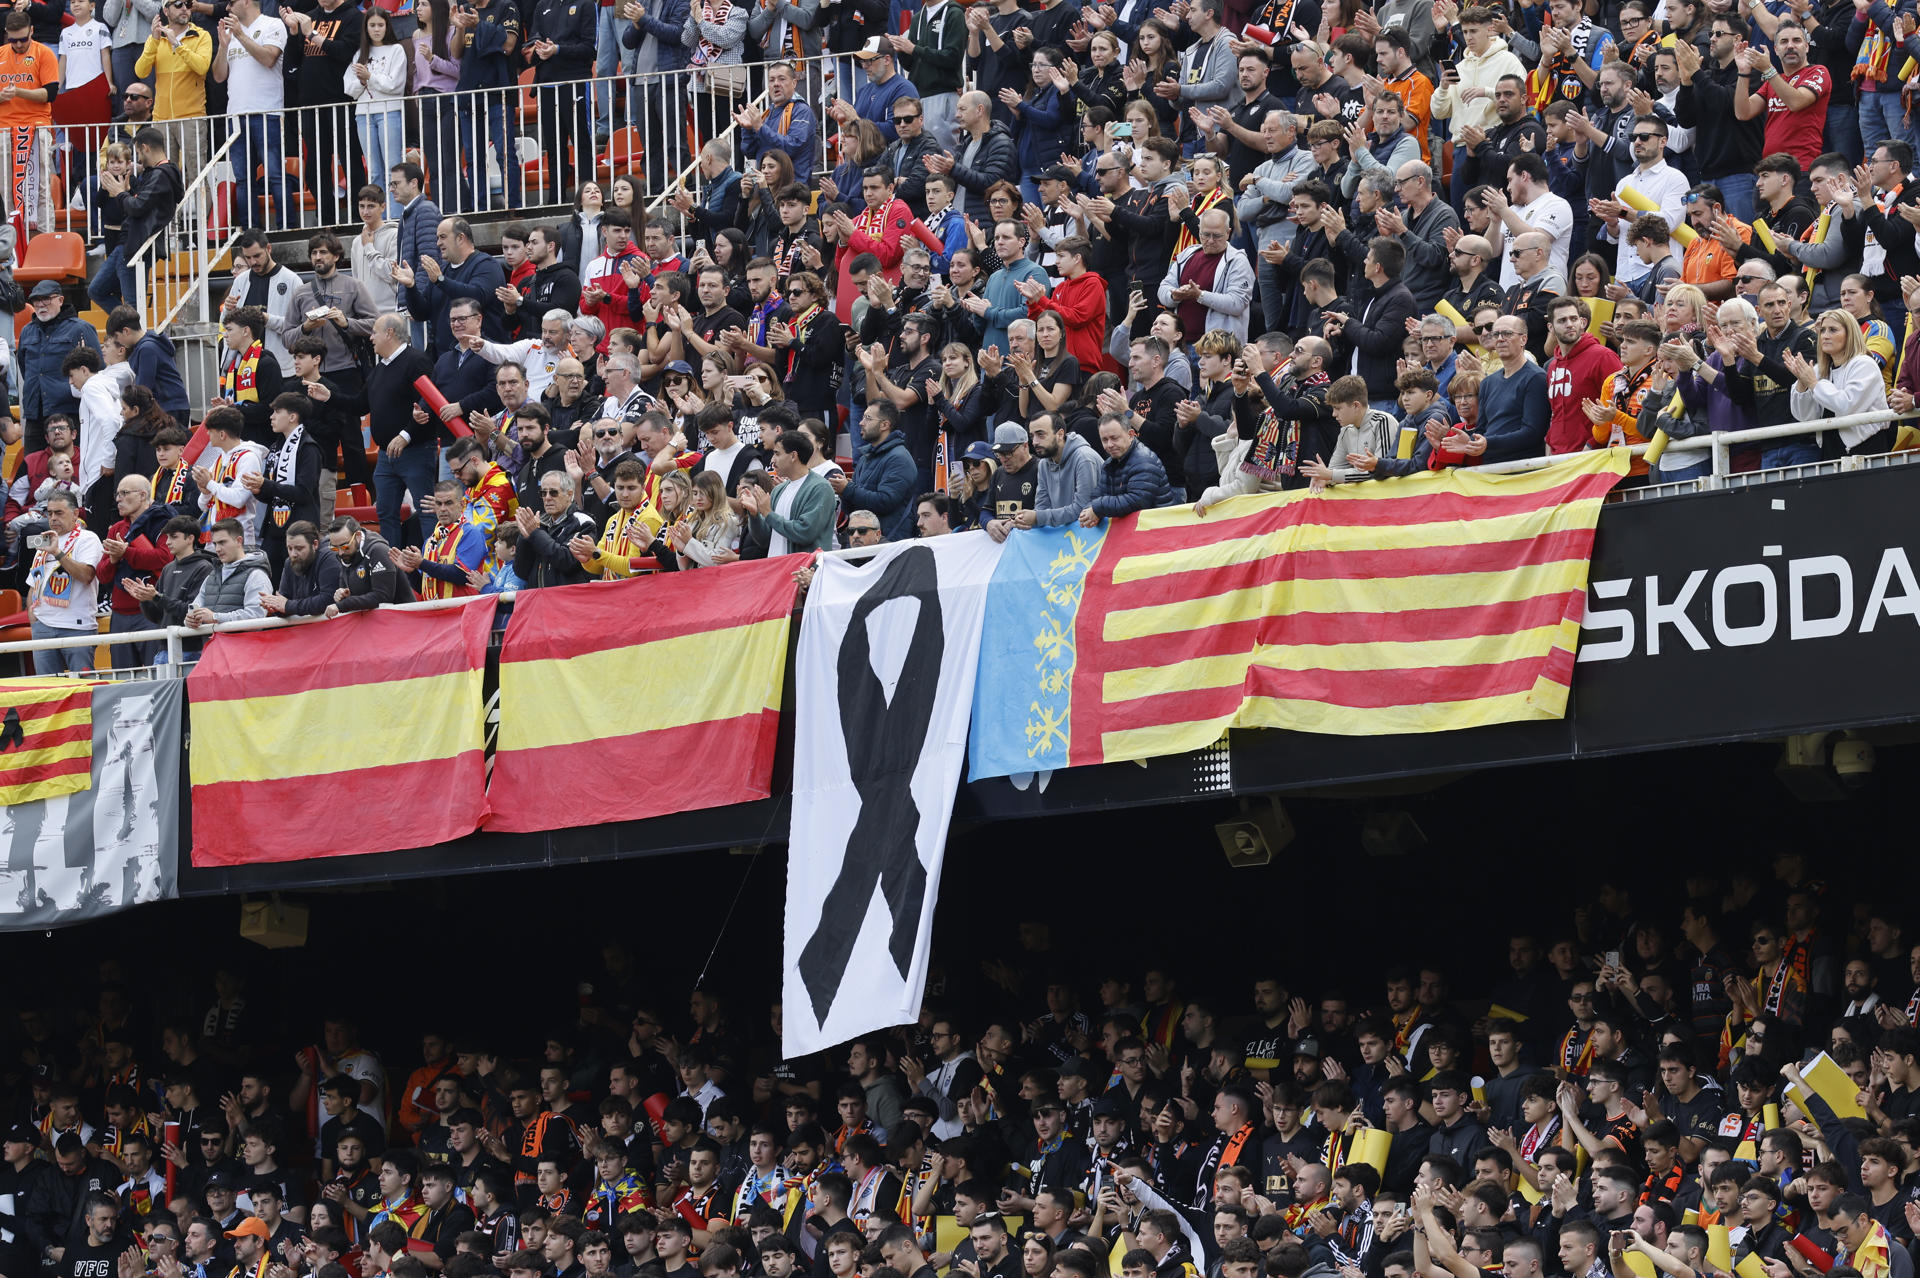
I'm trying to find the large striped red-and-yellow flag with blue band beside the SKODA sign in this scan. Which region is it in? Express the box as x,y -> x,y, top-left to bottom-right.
972,449 -> 1626,779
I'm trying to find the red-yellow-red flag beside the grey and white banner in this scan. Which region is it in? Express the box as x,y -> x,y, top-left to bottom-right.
186,595 -> 493,865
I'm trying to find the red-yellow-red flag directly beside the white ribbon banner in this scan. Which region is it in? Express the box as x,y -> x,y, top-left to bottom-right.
486,555 -> 806,831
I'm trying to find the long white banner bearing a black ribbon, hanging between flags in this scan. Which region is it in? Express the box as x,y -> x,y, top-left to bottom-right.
781,532 -> 1000,1059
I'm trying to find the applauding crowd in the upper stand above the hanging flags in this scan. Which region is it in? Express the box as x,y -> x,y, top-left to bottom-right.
0,0 -> 1920,672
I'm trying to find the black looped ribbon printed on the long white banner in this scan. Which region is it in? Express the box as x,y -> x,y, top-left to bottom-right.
801,545 -> 947,1025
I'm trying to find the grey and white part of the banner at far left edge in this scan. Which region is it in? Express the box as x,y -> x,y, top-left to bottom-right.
0,679 -> 186,931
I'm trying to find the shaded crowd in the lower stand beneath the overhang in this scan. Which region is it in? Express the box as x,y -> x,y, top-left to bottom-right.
0,867 -> 1920,1278
